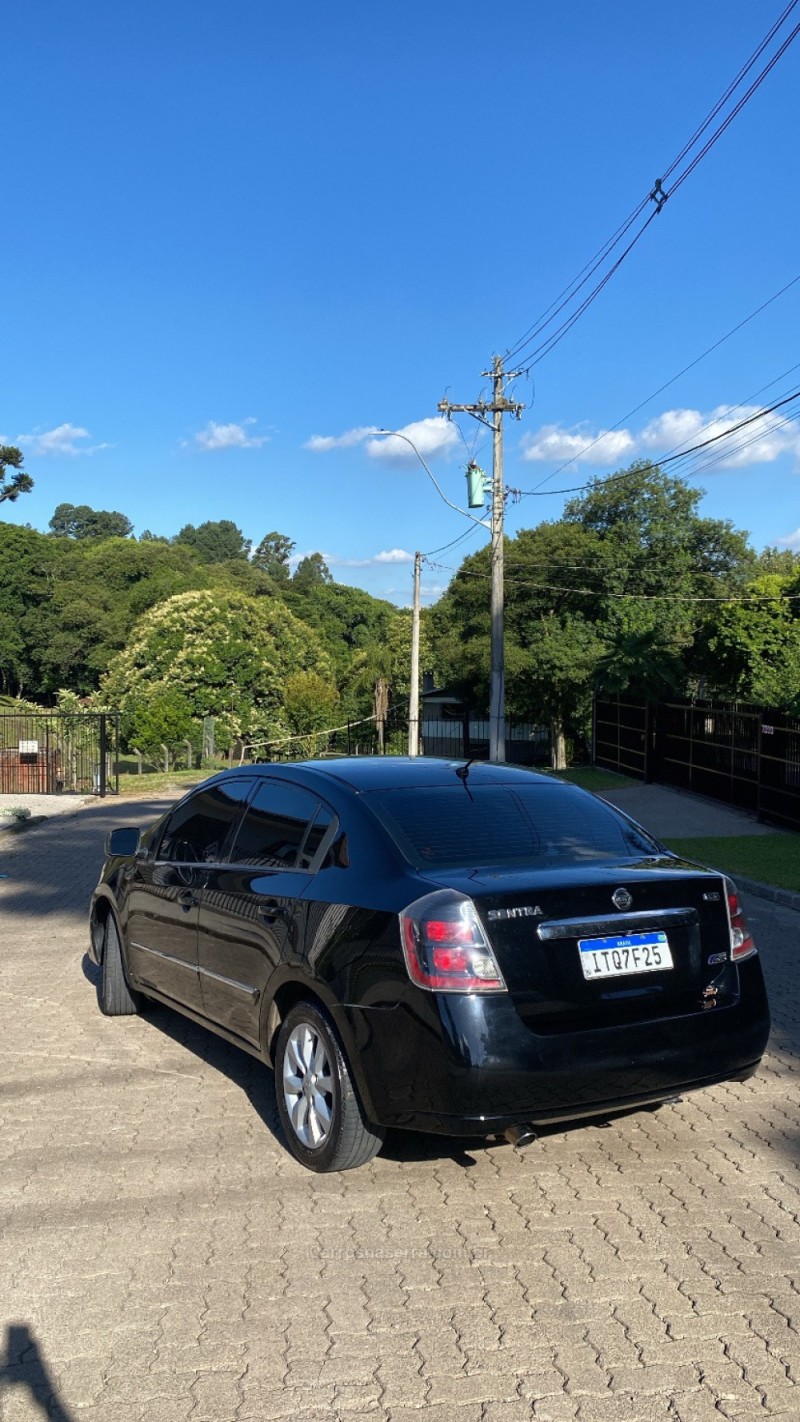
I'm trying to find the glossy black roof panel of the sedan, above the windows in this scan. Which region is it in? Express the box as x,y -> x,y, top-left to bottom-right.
223,755 -> 561,791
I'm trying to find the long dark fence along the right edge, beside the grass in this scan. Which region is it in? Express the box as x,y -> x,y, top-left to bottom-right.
594,697 -> 800,829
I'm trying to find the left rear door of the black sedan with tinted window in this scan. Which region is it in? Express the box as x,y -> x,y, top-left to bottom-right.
198,778 -> 331,1045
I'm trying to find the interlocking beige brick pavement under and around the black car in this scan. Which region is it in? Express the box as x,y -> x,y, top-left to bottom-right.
0,806 -> 800,1422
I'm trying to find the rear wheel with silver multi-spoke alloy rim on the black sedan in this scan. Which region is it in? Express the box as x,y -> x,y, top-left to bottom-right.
276,1003 -> 384,1172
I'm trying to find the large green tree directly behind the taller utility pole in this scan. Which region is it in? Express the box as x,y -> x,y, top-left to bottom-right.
431,462 -> 753,765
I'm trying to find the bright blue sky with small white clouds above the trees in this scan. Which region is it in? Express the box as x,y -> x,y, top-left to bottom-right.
0,0 -> 800,603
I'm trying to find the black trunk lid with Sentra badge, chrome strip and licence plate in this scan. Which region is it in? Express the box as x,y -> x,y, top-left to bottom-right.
420,856 -> 737,1032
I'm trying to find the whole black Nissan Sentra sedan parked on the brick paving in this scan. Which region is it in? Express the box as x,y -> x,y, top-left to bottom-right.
91,758 -> 769,1170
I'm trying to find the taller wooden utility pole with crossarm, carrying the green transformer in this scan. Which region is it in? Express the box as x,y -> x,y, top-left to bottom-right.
438,356 -> 524,761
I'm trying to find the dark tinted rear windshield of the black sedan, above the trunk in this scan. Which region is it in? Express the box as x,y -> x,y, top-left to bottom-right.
364,782 -> 659,867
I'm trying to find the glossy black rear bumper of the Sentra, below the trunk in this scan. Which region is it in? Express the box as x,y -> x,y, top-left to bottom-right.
345,957 -> 770,1135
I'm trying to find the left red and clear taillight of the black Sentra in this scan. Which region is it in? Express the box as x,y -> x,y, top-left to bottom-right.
399,889 -> 506,993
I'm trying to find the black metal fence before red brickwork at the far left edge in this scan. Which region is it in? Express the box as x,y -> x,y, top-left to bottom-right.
0,711 -> 119,795
